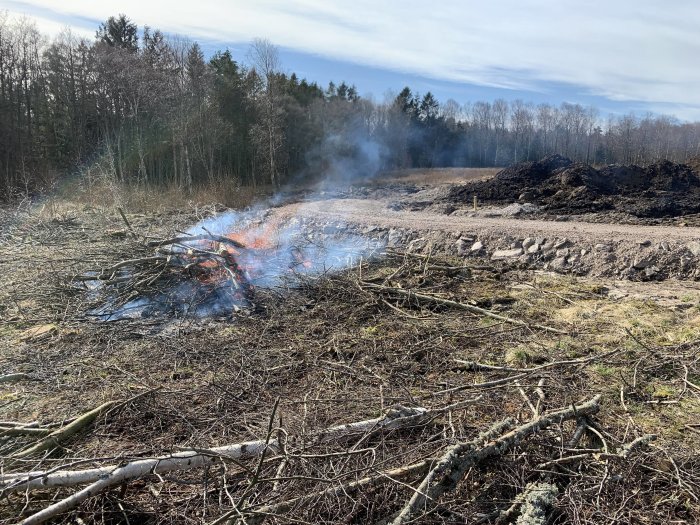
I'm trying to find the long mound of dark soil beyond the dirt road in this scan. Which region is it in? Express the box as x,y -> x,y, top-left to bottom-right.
448,155 -> 700,218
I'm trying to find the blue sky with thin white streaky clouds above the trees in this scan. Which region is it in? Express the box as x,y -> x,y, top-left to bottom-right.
5,0 -> 700,120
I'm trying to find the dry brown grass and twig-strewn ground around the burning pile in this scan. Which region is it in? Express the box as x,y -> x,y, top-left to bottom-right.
0,203 -> 700,524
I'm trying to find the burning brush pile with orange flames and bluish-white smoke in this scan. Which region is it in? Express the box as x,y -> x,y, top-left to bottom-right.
73,211 -> 381,320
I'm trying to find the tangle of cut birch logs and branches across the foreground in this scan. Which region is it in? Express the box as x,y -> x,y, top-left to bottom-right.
0,380 -> 655,525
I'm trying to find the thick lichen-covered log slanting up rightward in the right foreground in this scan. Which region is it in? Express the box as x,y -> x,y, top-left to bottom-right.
391,395 -> 600,525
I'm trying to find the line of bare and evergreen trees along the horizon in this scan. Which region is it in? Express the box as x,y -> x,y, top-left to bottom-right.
0,13 -> 700,198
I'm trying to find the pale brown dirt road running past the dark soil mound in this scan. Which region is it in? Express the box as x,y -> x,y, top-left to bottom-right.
281,199 -> 700,244
